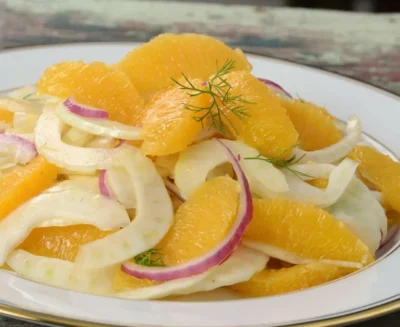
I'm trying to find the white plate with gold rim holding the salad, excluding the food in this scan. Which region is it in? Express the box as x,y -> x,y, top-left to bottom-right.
0,43 -> 400,327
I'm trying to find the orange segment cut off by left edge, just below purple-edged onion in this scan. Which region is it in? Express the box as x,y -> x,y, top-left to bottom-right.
0,156 -> 58,221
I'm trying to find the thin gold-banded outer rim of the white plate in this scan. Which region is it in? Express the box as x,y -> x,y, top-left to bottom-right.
0,41 -> 400,327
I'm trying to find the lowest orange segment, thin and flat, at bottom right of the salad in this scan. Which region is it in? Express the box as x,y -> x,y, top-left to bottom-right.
231,263 -> 352,297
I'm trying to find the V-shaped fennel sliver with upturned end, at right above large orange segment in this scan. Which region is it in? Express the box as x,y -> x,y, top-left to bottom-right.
283,159 -> 358,208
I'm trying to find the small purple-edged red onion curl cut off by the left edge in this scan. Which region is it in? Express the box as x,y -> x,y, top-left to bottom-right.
0,134 -> 37,164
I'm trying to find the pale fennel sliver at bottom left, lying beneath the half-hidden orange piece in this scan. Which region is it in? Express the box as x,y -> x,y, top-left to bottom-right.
6,250 -> 116,295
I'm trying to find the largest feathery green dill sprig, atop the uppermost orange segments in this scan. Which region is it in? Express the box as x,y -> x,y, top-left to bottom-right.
172,60 -> 251,134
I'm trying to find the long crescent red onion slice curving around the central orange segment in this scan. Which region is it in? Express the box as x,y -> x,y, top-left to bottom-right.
121,139 -> 253,282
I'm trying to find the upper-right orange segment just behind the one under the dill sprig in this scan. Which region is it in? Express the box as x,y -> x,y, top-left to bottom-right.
282,100 -> 343,151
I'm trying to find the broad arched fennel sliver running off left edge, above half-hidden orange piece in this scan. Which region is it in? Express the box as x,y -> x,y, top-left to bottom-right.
0,182 -> 129,266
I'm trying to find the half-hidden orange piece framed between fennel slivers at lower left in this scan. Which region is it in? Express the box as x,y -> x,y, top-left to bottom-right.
18,225 -> 112,261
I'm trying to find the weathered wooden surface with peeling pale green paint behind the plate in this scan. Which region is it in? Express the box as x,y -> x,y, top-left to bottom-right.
0,0 -> 400,327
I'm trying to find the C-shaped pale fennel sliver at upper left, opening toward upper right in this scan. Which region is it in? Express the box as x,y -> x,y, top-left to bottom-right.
35,108 -> 124,173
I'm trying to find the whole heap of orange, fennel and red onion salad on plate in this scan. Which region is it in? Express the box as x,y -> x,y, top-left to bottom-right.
0,34 -> 400,299
